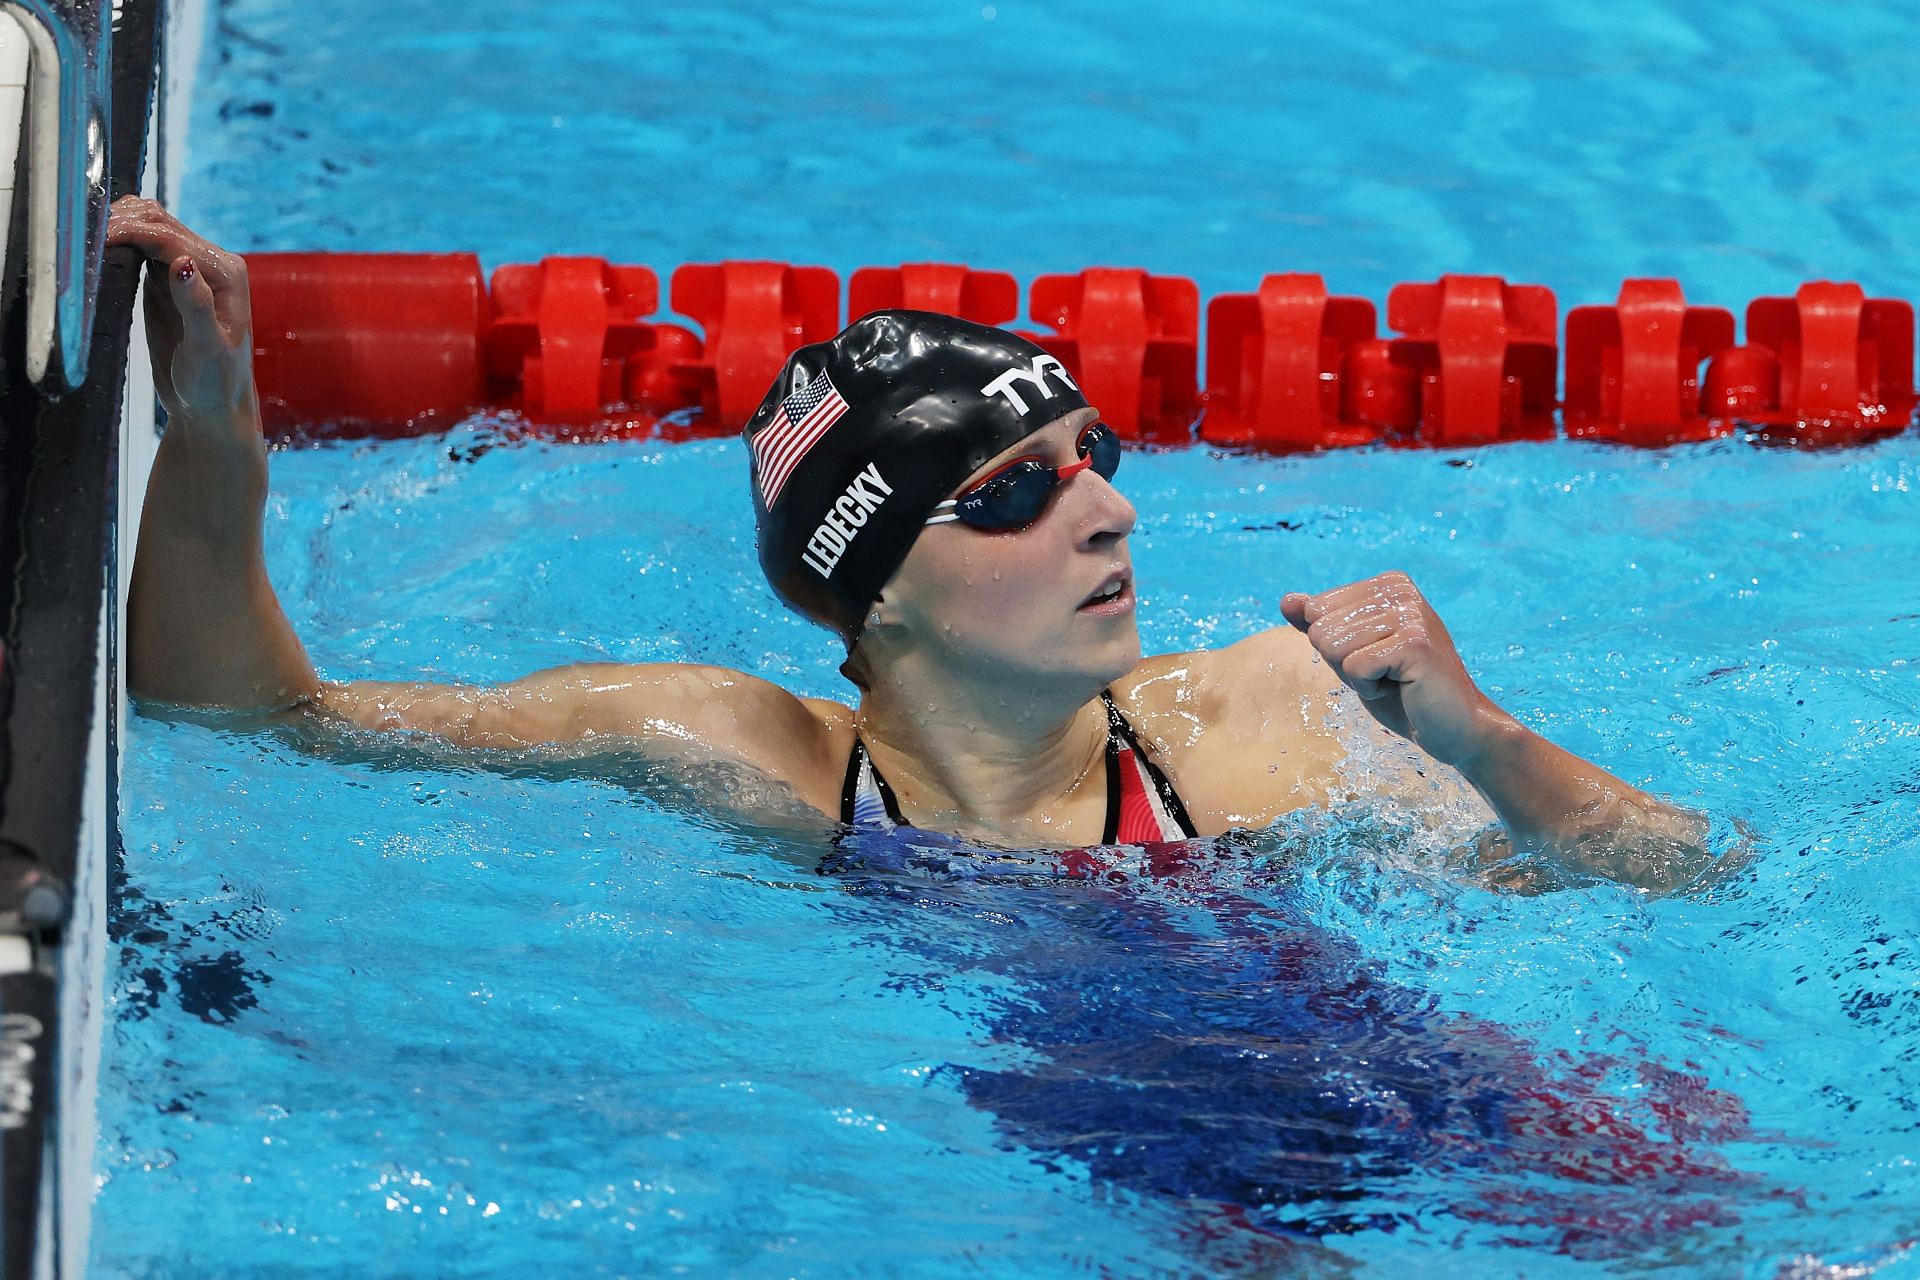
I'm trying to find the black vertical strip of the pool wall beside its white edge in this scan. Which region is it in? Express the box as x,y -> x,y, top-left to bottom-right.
0,0 -> 161,1280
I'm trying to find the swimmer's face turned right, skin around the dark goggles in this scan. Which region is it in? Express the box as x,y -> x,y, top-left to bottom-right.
877,409 -> 1140,687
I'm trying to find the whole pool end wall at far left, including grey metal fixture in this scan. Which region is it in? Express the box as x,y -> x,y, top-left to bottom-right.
0,0 -> 161,1280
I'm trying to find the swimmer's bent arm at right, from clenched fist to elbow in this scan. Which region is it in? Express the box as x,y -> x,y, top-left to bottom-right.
1281,574 -> 1711,890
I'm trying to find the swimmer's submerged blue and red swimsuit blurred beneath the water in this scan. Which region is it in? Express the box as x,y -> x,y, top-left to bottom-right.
820,831 -> 1786,1259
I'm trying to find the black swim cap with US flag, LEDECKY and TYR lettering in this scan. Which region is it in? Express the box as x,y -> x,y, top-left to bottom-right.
747,311 -> 1087,647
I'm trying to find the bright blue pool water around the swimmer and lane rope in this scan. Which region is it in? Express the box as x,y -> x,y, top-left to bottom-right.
94,0 -> 1920,1278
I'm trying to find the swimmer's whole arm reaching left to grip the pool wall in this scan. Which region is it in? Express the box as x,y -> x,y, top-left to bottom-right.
108,198 -> 852,814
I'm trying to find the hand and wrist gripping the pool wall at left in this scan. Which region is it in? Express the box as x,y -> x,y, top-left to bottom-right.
108,196 -> 259,430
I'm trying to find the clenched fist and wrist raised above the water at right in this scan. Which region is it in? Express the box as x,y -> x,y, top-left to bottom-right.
1281,572 -> 1513,768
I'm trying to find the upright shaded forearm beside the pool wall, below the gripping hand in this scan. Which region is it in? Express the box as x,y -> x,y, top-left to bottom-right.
127,408 -> 319,708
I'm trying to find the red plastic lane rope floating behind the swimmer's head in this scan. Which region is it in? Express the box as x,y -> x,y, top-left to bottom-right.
248,253 -> 1914,451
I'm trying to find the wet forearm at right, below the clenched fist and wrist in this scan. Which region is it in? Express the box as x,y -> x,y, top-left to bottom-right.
1457,720 -> 1711,890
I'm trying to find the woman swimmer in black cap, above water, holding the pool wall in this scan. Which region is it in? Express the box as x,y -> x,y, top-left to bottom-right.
108,198 -> 1711,890
